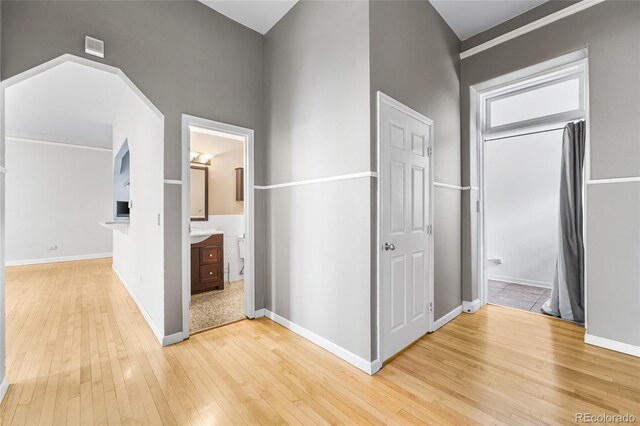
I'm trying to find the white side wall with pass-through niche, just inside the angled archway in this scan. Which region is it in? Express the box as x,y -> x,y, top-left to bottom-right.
113,89 -> 164,339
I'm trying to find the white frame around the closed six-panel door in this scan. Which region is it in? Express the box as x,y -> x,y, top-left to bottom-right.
372,91 -> 435,374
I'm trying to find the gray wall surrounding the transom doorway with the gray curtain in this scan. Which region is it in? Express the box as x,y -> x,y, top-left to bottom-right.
461,1 -> 640,345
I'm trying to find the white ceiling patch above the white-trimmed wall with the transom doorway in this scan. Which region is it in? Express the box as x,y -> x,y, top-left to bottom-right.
430,0 -> 546,40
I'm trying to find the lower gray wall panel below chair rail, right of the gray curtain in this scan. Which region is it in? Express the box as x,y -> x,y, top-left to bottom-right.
587,184 -> 640,346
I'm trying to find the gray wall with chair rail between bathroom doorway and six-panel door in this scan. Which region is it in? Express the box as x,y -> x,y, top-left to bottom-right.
263,1 -> 372,360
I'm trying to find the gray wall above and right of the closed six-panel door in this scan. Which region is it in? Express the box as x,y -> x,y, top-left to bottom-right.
369,0 -> 462,319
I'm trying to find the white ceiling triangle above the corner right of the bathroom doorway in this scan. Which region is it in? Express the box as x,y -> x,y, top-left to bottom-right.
199,0 -> 298,34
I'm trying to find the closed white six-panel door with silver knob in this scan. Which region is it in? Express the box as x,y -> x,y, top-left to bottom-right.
379,95 -> 433,361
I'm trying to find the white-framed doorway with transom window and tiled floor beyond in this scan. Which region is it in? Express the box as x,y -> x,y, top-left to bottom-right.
472,51 -> 588,315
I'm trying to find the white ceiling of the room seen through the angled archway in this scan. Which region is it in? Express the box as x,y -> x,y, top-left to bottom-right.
5,62 -> 128,149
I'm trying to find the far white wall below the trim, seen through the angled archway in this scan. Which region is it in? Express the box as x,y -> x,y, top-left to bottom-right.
6,138 -> 112,265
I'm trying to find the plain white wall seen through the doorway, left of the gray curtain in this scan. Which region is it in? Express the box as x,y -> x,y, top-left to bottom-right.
485,130 -> 562,287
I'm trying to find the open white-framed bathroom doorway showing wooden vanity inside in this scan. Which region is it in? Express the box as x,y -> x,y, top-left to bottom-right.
182,115 -> 254,337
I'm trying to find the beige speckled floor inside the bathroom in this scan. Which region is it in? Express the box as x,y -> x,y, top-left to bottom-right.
190,281 -> 245,333
